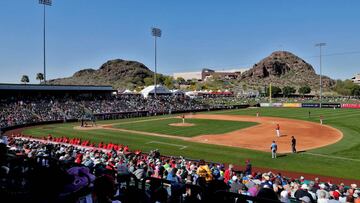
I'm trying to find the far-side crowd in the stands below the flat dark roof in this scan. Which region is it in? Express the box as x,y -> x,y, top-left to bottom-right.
0,94 -> 211,128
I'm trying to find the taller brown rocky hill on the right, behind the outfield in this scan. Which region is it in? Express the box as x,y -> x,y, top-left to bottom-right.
241,51 -> 335,89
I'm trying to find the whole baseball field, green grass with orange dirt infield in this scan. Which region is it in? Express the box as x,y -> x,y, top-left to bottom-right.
19,108 -> 360,180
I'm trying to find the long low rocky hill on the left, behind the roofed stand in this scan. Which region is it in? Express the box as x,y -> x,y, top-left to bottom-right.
48,59 -> 153,89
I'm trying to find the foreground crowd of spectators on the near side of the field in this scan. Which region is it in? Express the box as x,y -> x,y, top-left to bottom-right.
0,136 -> 360,203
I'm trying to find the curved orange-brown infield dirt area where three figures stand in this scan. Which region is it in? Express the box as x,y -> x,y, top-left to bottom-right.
188,114 -> 343,153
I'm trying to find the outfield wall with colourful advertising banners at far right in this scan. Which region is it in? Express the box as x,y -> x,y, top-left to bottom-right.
260,103 -> 360,109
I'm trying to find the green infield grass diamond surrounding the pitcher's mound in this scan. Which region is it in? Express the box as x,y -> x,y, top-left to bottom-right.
113,118 -> 256,137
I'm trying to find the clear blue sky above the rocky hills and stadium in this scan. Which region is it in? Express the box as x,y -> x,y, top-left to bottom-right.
0,0 -> 360,83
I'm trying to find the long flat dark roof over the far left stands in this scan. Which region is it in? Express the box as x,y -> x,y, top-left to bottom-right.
0,83 -> 115,91
